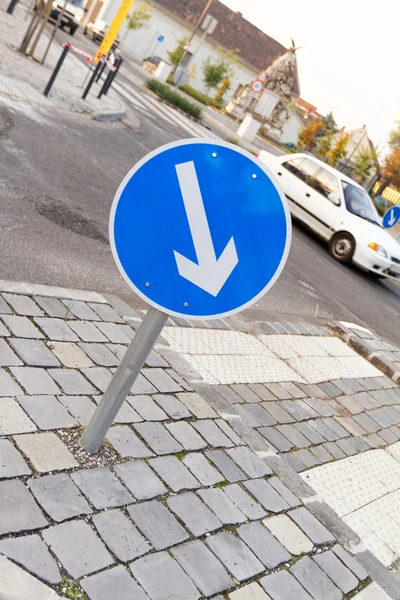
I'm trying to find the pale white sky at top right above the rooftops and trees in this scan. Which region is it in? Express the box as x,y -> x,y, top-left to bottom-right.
220,0 -> 400,155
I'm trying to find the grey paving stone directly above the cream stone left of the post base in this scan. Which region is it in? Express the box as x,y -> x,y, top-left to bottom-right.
18,396 -> 78,430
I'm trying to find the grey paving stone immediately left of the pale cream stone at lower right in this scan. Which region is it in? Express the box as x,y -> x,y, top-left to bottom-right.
237,523 -> 291,569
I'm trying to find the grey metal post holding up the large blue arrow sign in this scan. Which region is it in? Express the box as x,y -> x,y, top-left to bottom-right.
80,308 -> 168,454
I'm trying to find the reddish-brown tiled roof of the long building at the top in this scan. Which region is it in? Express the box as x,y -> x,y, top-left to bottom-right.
156,0 -> 286,71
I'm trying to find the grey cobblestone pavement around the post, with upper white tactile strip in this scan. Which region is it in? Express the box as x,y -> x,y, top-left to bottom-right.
0,282 -> 400,600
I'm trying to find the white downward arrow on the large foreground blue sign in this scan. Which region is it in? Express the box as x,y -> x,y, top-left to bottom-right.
174,161 -> 239,296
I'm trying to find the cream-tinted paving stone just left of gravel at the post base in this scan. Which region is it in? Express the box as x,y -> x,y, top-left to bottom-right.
14,432 -> 78,473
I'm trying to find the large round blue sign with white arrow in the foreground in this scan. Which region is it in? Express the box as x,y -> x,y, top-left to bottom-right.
110,139 -> 291,319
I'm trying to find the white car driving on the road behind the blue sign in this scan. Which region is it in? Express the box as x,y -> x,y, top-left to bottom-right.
258,150 -> 400,281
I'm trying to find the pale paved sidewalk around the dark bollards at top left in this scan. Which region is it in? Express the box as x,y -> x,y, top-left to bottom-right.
0,0 -> 125,119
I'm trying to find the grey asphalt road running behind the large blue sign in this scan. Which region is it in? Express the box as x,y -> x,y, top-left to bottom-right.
0,38 -> 400,344
